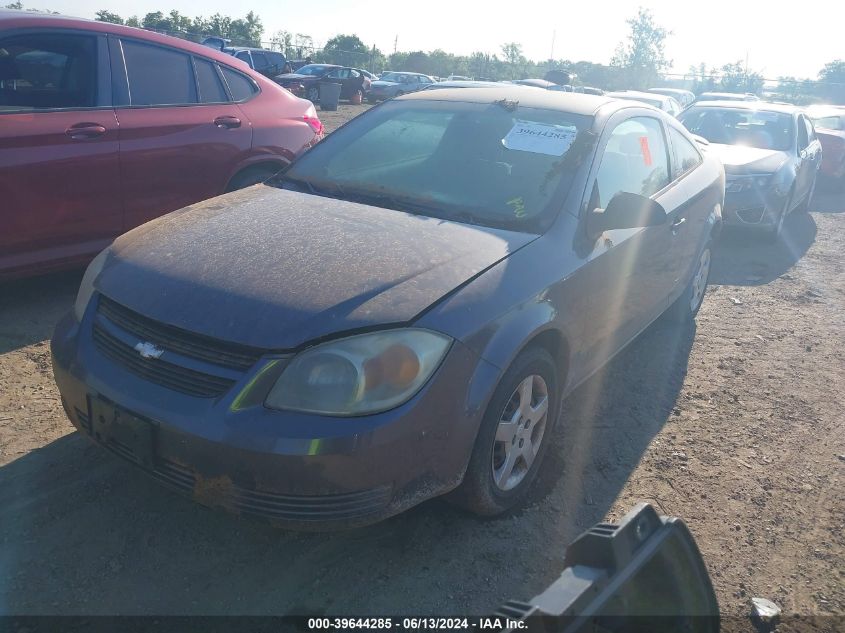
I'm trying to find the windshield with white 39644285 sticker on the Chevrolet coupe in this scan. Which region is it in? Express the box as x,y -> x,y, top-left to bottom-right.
270,101 -> 591,232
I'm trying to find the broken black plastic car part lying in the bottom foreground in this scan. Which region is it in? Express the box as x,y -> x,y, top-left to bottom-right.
495,503 -> 720,633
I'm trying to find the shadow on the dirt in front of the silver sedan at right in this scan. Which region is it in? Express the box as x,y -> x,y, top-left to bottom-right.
710,213 -> 816,286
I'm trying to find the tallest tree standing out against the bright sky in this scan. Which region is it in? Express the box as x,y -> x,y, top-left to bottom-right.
610,7 -> 671,89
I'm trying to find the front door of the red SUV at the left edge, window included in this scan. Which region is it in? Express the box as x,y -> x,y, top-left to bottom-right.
0,29 -> 122,271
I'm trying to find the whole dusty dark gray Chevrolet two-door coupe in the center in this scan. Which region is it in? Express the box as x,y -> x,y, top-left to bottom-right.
52,87 -> 724,529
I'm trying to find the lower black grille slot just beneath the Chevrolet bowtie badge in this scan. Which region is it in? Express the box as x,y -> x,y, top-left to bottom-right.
94,323 -> 235,398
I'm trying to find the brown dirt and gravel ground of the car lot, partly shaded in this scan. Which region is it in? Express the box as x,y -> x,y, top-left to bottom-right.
0,105 -> 845,615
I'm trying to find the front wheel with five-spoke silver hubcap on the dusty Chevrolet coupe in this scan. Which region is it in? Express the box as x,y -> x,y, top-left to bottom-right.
447,347 -> 559,516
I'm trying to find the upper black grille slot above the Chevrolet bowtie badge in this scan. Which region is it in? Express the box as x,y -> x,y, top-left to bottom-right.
97,295 -> 262,371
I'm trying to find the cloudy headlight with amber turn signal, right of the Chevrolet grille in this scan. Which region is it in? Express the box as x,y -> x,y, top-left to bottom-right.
265,329 -> 451,416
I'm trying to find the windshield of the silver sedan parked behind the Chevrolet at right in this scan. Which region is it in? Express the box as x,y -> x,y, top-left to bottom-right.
679,107 -> 794,151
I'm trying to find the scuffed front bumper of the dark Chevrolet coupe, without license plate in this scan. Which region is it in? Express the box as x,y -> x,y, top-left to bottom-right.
51,301 -> 498,530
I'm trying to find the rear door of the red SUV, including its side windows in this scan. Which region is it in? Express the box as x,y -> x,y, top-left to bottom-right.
113,38 -> 258,229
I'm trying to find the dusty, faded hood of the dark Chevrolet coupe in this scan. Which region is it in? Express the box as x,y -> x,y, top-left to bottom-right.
95,185 -> 537,350
